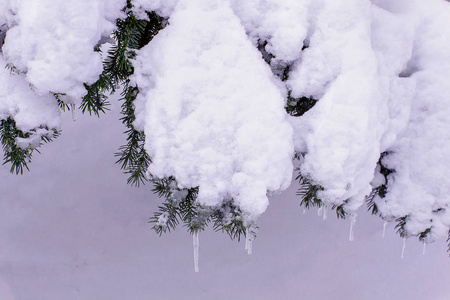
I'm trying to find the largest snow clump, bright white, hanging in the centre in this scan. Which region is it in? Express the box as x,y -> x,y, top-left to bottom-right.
135,0 -> 293,218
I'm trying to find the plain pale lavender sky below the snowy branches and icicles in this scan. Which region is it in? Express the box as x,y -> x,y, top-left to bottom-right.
0,101 -> 450,300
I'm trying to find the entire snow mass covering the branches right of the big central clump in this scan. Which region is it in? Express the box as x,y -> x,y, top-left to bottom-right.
288,0 -> 450,240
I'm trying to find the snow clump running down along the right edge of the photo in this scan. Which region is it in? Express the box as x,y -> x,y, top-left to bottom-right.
374,1 -> 450,241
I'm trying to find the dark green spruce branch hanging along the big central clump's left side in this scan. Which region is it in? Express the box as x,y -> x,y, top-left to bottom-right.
102,9 -> 164,186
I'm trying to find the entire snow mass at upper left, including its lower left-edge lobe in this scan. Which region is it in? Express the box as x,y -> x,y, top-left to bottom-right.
0,0 -> 125,144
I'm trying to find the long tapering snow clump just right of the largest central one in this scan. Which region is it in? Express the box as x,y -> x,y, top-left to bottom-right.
288,1 -> 387,211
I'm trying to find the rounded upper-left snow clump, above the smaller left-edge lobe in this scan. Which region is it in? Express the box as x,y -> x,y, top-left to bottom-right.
2,0 -> 125,103
